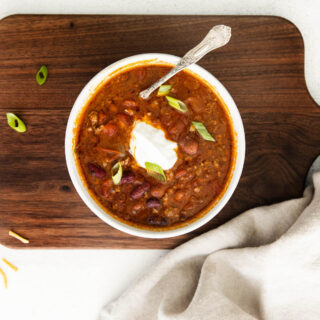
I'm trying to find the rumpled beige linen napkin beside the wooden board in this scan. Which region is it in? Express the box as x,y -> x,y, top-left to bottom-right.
100,164 -> 320,320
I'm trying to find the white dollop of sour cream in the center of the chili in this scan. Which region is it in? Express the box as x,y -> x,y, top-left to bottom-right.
130,121 -> 178,170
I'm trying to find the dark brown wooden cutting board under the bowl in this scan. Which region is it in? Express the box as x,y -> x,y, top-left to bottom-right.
0,15 -> 320,248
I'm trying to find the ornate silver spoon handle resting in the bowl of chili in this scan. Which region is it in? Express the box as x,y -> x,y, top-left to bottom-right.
140,25 -> 231,99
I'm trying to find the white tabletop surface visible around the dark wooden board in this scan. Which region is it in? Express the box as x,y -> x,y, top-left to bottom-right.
0,0 -> 320,320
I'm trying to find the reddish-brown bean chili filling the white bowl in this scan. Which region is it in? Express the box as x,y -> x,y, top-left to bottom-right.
75,65 -> 235,228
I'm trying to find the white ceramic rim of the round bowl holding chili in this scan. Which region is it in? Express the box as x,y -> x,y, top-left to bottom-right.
65,53 -> 245,238
